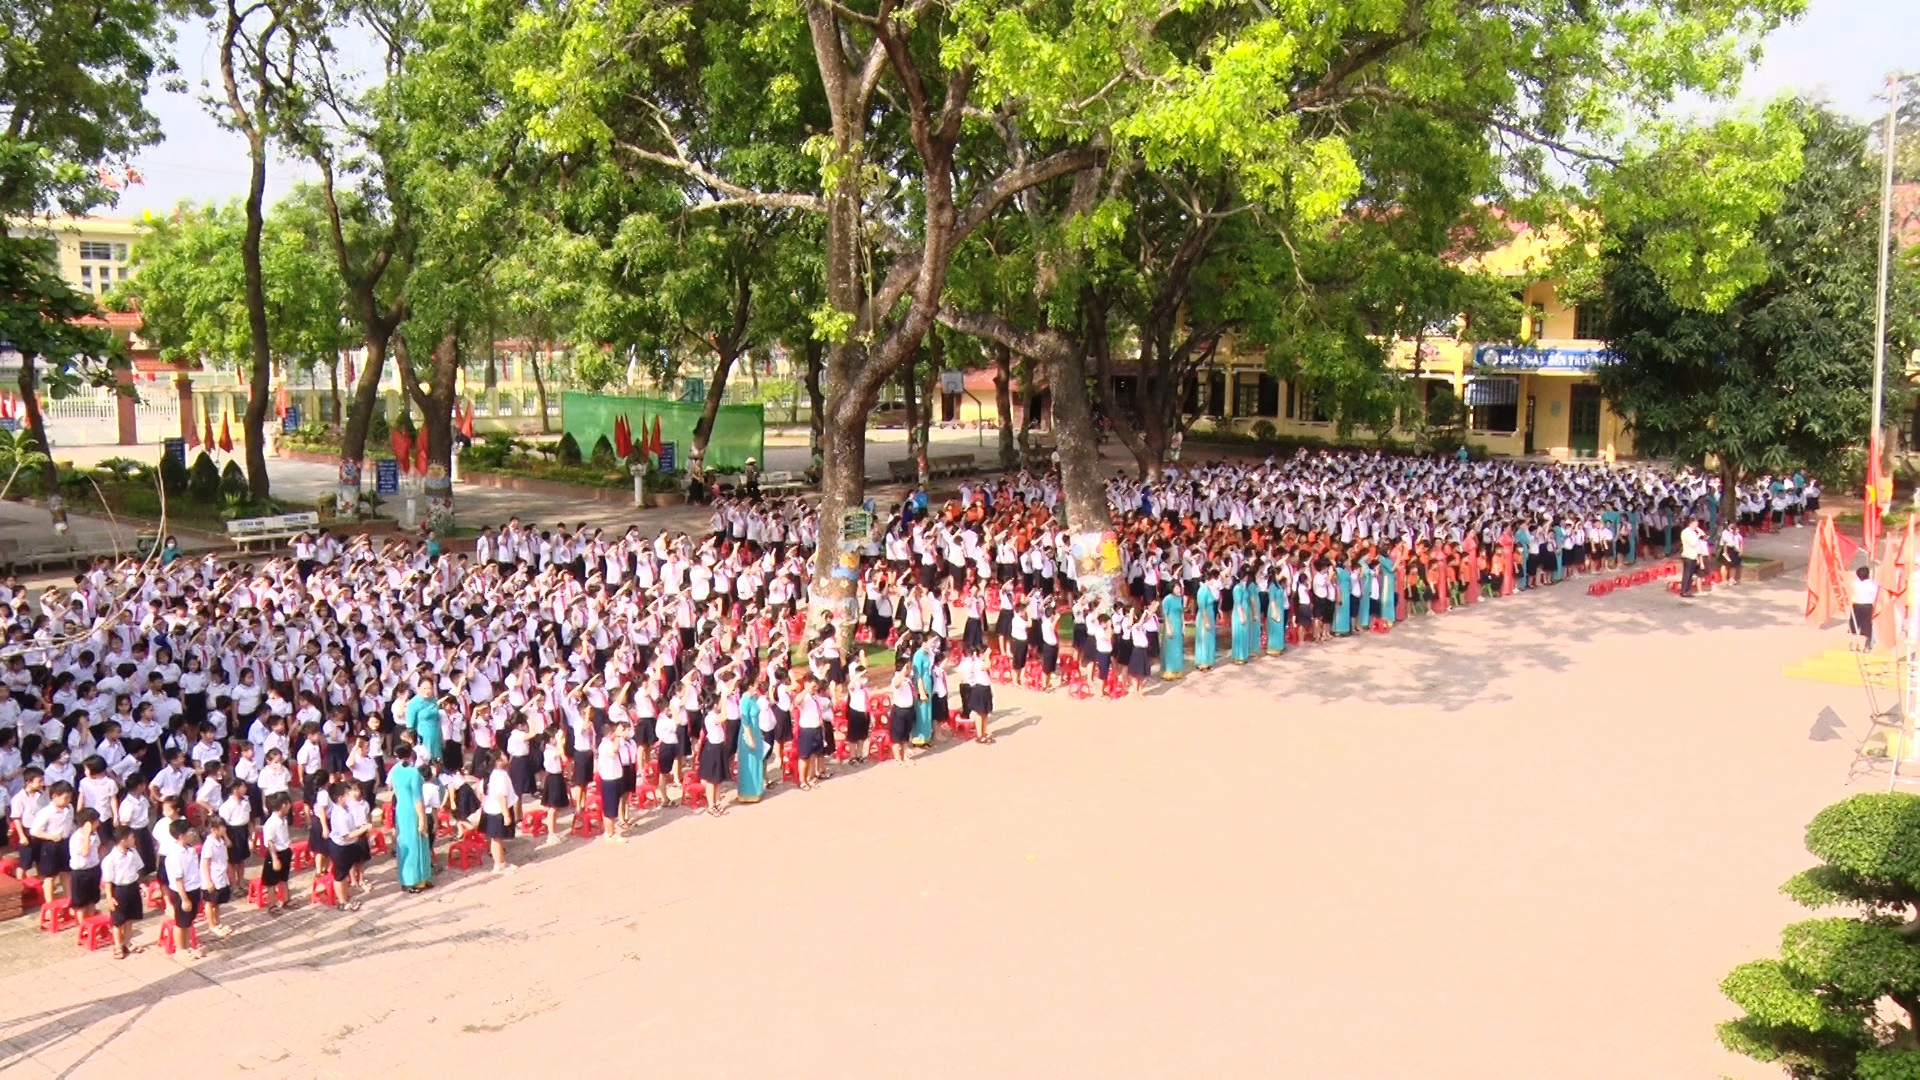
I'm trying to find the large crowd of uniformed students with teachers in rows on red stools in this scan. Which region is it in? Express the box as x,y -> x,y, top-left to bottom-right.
0,452 -> 1816,955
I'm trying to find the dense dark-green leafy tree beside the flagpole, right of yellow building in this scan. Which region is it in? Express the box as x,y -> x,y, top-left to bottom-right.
1599,104 -> 1916,511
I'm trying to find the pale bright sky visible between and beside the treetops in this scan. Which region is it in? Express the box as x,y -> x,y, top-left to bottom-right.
102,0 -> 1920,217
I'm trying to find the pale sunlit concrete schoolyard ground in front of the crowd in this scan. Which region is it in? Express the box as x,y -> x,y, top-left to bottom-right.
0,528 -> 1887,1080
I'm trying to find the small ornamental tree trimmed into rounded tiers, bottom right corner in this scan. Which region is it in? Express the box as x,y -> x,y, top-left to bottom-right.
1720,794 -> 1920,1080
